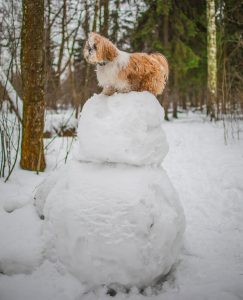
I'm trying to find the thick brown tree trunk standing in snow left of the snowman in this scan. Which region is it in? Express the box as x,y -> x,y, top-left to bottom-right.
20,0 -> 45,172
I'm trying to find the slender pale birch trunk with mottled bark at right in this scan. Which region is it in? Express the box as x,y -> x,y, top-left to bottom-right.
207,0 -> 217,120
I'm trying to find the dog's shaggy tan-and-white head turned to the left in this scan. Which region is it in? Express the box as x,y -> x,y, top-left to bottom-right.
83,32 -> 118,64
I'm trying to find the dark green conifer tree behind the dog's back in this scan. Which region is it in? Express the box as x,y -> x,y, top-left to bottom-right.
132,0 -> 201,118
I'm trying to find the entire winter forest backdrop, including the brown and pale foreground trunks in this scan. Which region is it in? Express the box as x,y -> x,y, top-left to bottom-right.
0,0 -> 243,180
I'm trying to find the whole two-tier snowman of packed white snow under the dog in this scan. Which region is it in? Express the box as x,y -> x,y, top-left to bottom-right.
35,92 -> 185,289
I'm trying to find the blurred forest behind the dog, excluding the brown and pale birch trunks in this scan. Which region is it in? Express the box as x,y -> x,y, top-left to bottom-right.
0,0 -> 243,118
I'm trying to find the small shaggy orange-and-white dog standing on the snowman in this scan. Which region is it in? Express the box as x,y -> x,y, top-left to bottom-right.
84,32 -> 169,96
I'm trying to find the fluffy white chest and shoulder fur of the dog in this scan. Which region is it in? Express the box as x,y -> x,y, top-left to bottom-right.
96,51 -> 130,90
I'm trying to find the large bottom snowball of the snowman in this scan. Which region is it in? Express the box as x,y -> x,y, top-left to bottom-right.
44,161 -> 184,287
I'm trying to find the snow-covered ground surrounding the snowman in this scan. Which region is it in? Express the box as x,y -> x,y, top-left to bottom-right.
0,114 -> 243,300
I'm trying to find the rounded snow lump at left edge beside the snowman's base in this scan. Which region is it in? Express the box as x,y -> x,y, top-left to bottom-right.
0,204 -> 43,274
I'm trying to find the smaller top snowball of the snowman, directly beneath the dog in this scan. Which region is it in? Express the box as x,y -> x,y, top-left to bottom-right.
77,92 -> 168,165
